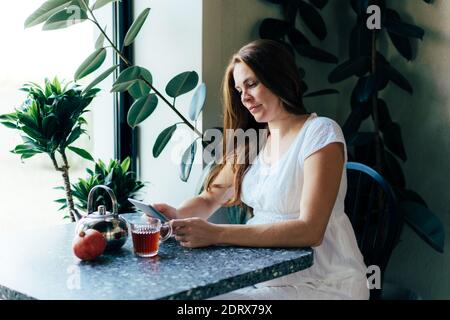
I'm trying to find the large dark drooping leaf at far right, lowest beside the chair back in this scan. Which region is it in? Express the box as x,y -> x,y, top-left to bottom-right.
400,201 -> 445,253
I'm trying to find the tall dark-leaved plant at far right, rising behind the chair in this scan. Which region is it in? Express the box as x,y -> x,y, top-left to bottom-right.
329,0 -> 445,252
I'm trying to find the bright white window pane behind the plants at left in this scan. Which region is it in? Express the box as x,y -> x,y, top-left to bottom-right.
0,0 -> 113,232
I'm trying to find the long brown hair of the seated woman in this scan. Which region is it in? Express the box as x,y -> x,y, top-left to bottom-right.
205,40 -> 307,206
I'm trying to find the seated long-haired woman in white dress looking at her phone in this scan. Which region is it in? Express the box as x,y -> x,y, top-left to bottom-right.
154,40 -> 369,300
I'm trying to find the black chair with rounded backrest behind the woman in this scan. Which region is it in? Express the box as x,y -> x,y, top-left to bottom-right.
345,162 -> 404,300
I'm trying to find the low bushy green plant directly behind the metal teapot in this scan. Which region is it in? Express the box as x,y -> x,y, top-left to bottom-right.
56,157 -> 145,213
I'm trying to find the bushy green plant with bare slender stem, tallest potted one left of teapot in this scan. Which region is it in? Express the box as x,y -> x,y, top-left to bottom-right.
0,78 -> 99,221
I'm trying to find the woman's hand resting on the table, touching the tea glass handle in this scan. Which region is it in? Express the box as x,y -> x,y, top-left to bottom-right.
170,218 -> 222,248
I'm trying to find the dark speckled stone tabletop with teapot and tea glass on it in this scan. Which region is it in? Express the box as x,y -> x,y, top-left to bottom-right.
0,215 -> 313,300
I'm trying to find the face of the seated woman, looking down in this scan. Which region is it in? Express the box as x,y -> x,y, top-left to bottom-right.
233,62 -> 285,122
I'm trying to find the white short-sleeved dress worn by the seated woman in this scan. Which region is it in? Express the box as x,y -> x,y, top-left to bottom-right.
214,113 -> 369,300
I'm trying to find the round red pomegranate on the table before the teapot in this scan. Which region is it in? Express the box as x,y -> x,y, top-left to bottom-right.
72,229 -> 106,261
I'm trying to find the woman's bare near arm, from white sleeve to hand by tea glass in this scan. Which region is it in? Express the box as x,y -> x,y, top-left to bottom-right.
173,143 -> 344,247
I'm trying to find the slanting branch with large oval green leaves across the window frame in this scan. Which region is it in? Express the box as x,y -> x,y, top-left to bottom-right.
25,0 -> 206,181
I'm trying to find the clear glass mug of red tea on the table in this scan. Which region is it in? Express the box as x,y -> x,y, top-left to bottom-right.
130,217 -> 172,257
